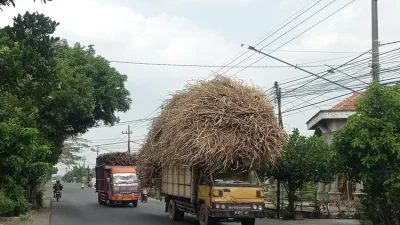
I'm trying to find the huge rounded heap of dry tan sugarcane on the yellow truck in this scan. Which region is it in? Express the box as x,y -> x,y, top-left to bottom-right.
138,76 -> 286,188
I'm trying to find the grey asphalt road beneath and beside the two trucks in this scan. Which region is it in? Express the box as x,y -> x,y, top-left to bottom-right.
50,184 -> 284,225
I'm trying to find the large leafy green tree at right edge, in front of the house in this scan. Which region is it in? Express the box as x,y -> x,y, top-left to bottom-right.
333,83 -> 400,225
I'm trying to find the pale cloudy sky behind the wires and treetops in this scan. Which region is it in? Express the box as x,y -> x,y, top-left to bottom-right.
0,0 -> 400,174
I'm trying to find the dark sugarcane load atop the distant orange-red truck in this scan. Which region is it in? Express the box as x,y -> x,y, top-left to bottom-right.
96,152 -> 137,166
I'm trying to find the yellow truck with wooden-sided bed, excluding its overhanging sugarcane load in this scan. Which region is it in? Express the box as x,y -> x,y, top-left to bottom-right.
161,166 -> 265,225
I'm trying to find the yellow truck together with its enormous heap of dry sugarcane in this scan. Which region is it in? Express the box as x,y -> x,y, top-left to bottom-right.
137,76 -> 286,225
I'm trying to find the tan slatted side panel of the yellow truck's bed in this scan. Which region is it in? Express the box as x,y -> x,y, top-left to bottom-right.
161,166 -> 193,199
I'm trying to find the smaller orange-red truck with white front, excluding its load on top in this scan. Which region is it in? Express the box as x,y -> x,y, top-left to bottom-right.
96,165 -> 140,207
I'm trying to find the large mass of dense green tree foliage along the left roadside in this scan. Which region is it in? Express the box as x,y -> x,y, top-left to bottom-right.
0,10 -> 131,215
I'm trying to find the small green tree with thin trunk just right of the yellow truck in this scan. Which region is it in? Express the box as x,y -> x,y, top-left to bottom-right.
266,129 -> 337,219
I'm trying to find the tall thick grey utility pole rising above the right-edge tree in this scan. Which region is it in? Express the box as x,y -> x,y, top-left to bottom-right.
371,0 -> 380,83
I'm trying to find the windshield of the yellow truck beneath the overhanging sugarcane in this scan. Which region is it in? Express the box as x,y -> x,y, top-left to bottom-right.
213,170 -> 260,186
